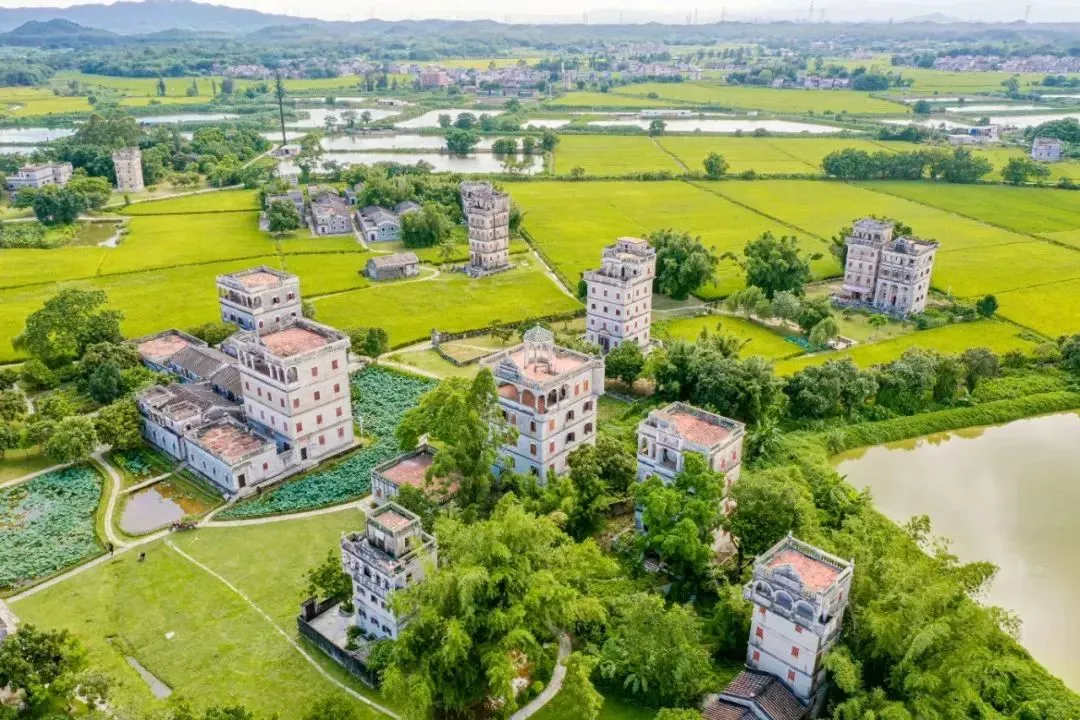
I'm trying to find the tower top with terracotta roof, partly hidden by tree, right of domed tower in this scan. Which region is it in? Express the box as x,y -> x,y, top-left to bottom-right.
637,403 -> 746,489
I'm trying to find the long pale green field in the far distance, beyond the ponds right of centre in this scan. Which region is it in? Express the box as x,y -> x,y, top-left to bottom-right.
609,82 -> 909,114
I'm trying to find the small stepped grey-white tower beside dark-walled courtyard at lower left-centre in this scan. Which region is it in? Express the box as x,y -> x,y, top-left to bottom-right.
341,502 -> 437,639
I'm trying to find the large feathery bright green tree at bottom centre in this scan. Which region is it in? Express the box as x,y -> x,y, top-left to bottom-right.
383,494 -> 618,720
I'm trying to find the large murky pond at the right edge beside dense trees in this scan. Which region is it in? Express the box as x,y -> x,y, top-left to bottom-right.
834,413 -> 1080,690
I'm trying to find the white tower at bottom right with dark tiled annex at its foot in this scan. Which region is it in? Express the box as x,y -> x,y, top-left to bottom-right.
701,534 -> 854,720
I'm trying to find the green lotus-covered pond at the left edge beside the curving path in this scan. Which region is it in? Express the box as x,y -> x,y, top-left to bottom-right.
0,465 -> 102,589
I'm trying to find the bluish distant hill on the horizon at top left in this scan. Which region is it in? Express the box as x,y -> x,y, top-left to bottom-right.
0,0 -> 320,35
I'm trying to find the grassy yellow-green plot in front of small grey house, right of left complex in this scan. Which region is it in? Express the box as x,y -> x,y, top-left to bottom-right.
313,258 -> 581,345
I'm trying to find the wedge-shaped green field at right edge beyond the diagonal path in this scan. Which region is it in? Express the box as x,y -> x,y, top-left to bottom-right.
863,182 -> 1080,234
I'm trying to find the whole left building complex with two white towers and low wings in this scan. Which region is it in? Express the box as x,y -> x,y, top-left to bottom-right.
133,267 -> 353,495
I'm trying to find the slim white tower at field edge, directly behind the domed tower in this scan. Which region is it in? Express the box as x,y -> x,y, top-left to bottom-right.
585,237 -> 657,353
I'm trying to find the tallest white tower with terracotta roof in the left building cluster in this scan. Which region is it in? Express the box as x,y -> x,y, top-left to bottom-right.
229,316 -> 353,467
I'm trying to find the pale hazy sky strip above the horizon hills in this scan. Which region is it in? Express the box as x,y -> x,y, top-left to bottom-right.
0,0 -> 1062,23
